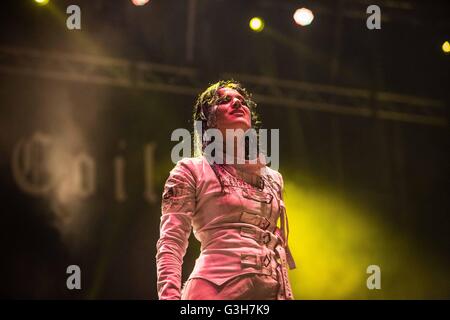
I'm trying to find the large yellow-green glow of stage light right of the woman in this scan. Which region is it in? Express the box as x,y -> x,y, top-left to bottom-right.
284,179 -> 447,300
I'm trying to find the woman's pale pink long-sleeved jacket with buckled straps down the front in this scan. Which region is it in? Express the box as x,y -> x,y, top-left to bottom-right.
156,156 -> 295,299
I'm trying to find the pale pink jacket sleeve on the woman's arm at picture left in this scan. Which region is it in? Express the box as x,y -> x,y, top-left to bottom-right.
156,160 -> 195,300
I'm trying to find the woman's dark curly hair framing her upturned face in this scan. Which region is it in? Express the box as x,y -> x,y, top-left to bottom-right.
193,79 -> 261,155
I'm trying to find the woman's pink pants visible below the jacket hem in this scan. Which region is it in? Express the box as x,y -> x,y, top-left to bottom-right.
181,274 -> 280,300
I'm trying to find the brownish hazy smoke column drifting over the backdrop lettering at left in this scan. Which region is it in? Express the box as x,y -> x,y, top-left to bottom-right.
29,82 -> 103,249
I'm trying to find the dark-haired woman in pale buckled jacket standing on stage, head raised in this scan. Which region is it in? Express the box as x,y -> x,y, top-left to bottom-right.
156,81 -> 295,300
